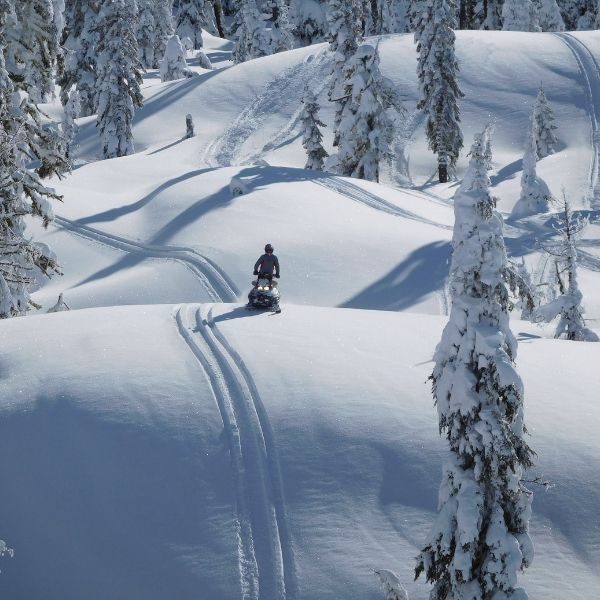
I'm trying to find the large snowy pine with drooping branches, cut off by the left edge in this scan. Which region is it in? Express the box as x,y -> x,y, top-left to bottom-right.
0,0 -> 60,318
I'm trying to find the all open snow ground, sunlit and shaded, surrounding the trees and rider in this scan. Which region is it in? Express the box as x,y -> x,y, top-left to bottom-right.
0,32 -> 600,600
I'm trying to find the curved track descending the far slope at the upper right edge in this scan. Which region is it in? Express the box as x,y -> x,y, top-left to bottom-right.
554,33 -> 600,208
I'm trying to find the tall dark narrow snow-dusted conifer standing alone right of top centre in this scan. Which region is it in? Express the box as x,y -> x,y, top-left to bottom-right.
415,0 -> 463,183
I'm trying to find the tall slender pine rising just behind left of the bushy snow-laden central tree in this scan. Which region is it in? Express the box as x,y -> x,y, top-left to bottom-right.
327,0 -> 361,146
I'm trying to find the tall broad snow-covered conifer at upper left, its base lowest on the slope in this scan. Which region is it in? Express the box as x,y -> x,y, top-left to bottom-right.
96,0 -> 142,158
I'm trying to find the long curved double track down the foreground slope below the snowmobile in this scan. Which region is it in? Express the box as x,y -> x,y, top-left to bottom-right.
175,305 -> 297,600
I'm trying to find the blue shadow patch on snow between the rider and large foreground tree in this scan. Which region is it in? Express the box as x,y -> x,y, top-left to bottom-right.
340,241 -> 452,310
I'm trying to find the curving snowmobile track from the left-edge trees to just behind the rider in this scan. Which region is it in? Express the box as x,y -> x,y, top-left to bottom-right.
54,216 -> 239,302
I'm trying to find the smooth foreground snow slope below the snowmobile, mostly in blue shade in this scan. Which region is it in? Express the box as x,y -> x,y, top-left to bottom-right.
0,305 -> 600,600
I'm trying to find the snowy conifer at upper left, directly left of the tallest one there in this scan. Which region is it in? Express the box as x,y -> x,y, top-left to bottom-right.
58,0 -> 99,117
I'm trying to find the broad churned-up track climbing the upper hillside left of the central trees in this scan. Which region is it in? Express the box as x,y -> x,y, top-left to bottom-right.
202,50 -> 327,167
